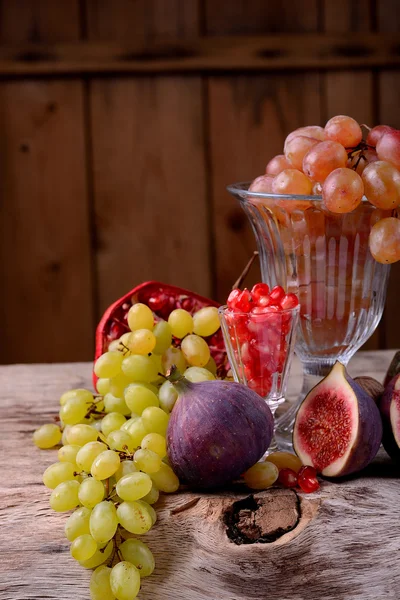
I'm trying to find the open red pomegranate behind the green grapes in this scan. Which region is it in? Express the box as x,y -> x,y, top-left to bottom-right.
93,281 -> 227,387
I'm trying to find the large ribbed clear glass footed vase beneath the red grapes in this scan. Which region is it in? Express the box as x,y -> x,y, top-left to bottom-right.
228,183 -> 390,449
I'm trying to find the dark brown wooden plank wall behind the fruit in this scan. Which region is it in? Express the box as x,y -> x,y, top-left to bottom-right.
0,0 -> 400,363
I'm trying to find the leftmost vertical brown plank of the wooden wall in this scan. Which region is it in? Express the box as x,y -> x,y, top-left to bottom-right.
0,0 -> 94,362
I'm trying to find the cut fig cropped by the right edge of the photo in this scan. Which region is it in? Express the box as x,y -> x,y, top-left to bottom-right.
380,373 -> 400,461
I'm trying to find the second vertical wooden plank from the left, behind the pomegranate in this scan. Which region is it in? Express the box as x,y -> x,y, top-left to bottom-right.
88,0 -> 211,310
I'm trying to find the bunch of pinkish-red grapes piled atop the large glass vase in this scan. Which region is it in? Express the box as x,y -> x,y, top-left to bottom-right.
249,115 -> 400,264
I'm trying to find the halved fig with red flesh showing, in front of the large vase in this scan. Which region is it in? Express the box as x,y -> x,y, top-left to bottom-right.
293,362 -> 382,477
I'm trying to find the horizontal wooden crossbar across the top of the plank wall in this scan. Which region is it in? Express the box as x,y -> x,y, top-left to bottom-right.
0,33 -> 400,75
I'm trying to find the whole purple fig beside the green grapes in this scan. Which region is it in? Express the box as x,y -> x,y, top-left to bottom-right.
167,378 -> 274,489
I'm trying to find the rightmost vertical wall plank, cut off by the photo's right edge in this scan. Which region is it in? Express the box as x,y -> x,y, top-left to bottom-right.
377,0 -> 400,348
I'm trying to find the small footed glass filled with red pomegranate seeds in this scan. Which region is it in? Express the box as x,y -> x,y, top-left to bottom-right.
218,306 -> 299,454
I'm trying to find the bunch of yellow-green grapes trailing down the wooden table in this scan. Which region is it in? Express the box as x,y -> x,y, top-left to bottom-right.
34,304 -> 220,600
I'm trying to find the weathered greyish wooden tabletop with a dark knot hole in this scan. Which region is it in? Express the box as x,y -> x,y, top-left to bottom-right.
0,351 -> 400,600
